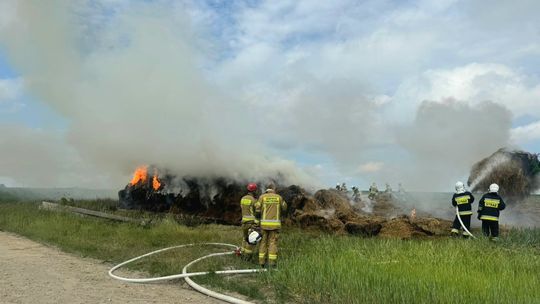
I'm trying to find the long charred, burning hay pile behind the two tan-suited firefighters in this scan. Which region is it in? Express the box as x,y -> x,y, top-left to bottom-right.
118,167 -> 449,237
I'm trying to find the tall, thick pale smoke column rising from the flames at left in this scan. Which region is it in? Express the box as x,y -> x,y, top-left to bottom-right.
0,1 -> 320,187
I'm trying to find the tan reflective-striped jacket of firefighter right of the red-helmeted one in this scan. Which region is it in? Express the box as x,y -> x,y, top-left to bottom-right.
255,191 -> 287,230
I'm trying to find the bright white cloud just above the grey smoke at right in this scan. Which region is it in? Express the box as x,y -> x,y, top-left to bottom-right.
393,63 -> 540,118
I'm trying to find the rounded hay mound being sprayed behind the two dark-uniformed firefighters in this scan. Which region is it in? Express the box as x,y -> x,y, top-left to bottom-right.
467,149 -> 540,199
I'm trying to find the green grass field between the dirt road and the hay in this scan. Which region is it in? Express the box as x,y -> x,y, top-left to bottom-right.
0,203 -> 540,303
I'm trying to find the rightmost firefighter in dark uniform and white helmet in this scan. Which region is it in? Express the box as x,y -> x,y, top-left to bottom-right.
478,184 -> 506,241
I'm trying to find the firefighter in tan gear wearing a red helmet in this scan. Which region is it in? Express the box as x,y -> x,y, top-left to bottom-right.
240,183 -> 258,260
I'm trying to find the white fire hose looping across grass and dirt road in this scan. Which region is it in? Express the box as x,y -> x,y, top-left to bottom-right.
109,243 -> 266,304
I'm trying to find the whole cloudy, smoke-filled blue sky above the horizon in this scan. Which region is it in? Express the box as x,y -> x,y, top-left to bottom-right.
0,0 -> 540,191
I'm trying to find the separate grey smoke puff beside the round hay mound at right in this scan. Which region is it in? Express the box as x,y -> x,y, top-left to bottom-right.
397,99 -> 512,189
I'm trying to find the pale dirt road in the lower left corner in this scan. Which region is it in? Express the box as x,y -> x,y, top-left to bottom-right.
0,232 -> 222,304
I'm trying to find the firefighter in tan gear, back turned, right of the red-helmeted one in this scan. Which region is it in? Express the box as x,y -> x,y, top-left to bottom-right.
255,183 -> 287,267
